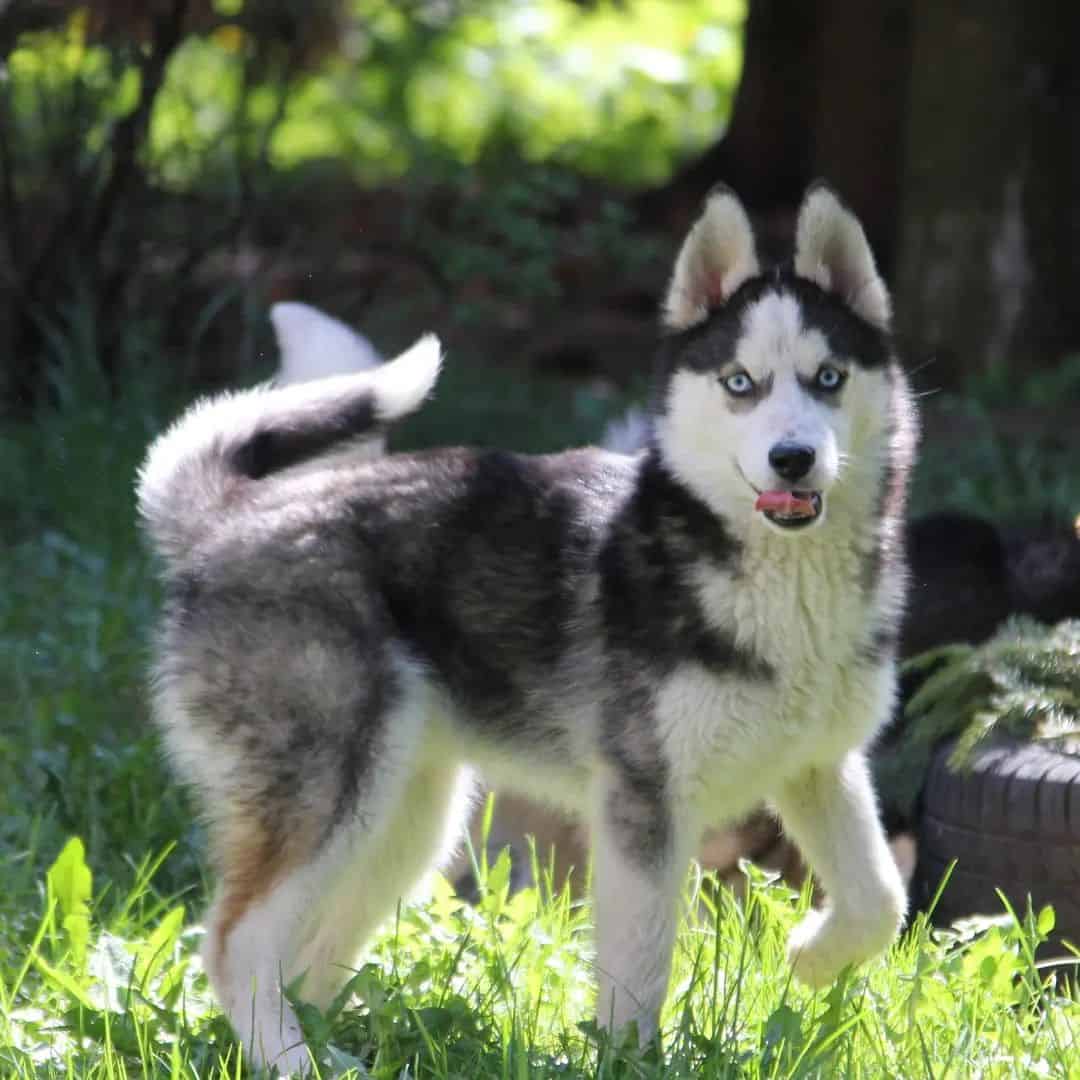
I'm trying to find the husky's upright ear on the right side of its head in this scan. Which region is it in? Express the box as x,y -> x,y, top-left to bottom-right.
795,185 -> 892,329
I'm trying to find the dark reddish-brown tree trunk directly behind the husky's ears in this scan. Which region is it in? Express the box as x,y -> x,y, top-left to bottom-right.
638,0 -> 909,270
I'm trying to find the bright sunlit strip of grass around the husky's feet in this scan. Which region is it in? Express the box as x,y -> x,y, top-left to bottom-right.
0,839 -> 1080,1080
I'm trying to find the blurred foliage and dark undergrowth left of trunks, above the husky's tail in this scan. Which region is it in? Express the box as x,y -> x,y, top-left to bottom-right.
0,0 -> 745,405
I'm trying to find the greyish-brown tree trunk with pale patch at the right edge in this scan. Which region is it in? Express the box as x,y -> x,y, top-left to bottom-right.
895,0 -> 1080,384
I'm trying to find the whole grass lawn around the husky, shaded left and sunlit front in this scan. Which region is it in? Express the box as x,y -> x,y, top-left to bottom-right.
0,354 -> 1080,1078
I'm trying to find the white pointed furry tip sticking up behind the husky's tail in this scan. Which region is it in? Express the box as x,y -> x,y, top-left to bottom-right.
270,302 -> 382,386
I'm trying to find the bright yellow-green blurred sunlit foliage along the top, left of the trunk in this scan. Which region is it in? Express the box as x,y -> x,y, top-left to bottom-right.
8,0 -> 745,189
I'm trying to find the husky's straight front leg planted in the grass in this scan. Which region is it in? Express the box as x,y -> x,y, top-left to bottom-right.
592,773 -> 690,1044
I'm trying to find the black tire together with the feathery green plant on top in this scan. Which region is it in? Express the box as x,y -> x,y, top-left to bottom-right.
876,618 -> 1080,945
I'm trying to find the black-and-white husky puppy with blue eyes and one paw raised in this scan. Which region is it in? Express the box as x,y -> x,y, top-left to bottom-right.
138,187 -> 914,1071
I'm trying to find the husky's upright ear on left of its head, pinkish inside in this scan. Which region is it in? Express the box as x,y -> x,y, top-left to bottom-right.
664,188 -> 758,330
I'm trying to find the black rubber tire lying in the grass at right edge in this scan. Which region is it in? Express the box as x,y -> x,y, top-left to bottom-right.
914,741 -> 1080,945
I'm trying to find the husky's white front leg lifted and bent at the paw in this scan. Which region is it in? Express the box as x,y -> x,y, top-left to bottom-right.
773,751 -> 907,986
